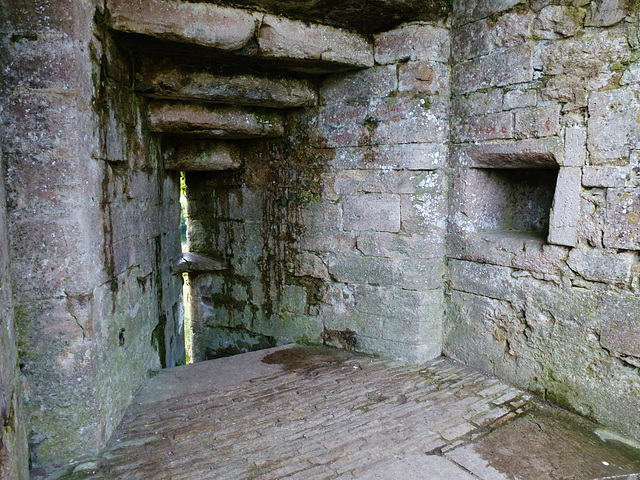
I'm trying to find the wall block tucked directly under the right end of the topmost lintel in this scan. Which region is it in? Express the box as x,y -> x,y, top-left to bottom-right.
320,65 -> 398,105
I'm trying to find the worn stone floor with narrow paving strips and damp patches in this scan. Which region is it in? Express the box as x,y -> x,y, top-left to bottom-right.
64,346 -> 640,480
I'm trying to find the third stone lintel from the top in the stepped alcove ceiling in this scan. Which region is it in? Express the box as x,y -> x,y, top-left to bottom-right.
148,101 -> 284,139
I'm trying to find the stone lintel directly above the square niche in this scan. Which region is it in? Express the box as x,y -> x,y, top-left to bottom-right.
467,137 -> 562,168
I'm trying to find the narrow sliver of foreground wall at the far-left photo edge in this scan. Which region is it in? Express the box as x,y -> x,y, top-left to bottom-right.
0,121 -> 29,480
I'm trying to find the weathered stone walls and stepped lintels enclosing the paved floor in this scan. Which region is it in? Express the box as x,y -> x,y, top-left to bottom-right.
0,0 -> 640,479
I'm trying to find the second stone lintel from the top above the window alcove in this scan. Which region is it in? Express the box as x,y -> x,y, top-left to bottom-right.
136,60 -> 317,108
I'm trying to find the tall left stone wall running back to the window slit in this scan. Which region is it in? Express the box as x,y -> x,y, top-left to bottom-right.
0,1 -> 184,475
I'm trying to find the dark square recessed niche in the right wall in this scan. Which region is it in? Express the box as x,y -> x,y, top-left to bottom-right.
474,168 -> 558,236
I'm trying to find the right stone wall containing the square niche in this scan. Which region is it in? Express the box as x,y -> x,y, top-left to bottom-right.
445,0 -> 640,436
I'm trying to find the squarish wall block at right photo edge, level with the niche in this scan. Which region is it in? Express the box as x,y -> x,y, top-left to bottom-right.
603,188 -> 640,250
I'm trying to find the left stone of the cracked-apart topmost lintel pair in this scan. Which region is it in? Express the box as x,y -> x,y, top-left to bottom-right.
107,0 -> 256,51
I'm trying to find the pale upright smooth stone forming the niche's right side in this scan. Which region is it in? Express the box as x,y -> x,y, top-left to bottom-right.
548,167 -> 582,247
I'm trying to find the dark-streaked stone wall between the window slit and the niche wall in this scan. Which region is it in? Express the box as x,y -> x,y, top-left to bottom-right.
186,20 -> 449,359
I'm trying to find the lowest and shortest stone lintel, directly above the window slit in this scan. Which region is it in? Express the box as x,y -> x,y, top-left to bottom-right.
164,140 -> 242,172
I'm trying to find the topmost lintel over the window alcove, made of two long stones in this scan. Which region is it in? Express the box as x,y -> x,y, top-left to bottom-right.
107,0 -> 374,73
